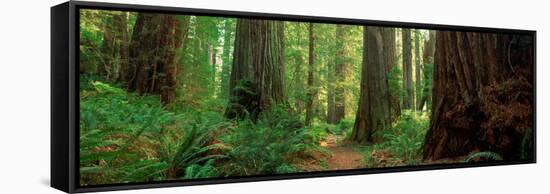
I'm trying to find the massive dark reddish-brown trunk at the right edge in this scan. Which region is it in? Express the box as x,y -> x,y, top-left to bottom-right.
423,31 -> 534,161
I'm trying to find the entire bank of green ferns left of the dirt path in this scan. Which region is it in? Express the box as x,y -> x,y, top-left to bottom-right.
79,76 -> 320,185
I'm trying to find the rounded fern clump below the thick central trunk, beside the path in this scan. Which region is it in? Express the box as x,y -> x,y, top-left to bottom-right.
220,106 -> 316,175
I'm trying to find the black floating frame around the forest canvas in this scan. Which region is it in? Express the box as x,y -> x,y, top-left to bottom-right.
51,1 -> 537,193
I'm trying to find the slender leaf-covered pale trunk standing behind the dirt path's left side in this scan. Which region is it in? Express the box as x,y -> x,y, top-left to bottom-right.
332,25 -> 352,123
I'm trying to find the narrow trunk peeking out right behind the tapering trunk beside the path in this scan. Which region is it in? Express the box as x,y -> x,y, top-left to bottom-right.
382,28 -> 401,120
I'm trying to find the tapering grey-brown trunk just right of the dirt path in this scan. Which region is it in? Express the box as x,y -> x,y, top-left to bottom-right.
351,27 -> 391,143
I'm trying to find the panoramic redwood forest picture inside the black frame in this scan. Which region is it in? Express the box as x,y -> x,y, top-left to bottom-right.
77,9 -> 535,186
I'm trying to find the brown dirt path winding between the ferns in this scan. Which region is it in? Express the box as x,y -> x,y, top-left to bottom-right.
303,135 -> 364,171
